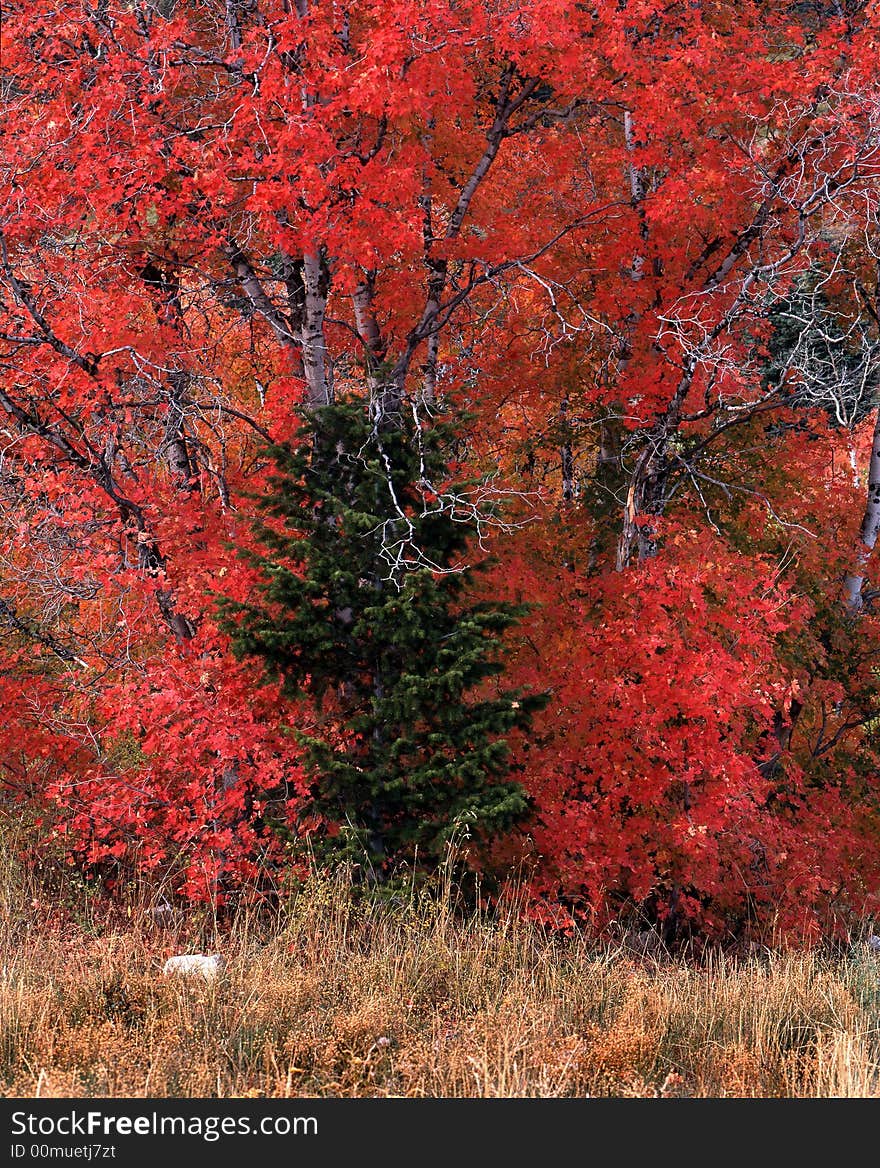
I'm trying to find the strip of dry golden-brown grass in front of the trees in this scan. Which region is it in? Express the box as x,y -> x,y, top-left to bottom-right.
0,831 -> 880,1098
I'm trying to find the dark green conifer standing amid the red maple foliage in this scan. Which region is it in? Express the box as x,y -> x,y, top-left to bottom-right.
222,399 -> 543,878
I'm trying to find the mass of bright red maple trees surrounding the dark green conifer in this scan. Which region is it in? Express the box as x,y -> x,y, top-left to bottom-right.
0,0 -> 880,937
